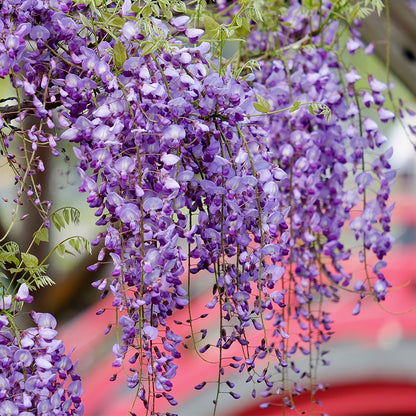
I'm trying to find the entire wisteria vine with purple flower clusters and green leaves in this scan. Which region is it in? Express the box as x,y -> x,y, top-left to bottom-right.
0,0 -> 404,416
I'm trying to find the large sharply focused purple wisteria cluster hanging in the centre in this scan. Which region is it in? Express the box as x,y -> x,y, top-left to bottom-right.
63,17 -> 287,412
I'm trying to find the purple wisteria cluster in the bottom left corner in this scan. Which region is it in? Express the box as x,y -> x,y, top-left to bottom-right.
0,283 -> 84,416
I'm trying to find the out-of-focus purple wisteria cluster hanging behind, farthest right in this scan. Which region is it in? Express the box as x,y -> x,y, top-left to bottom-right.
208,2 -> 395,405
